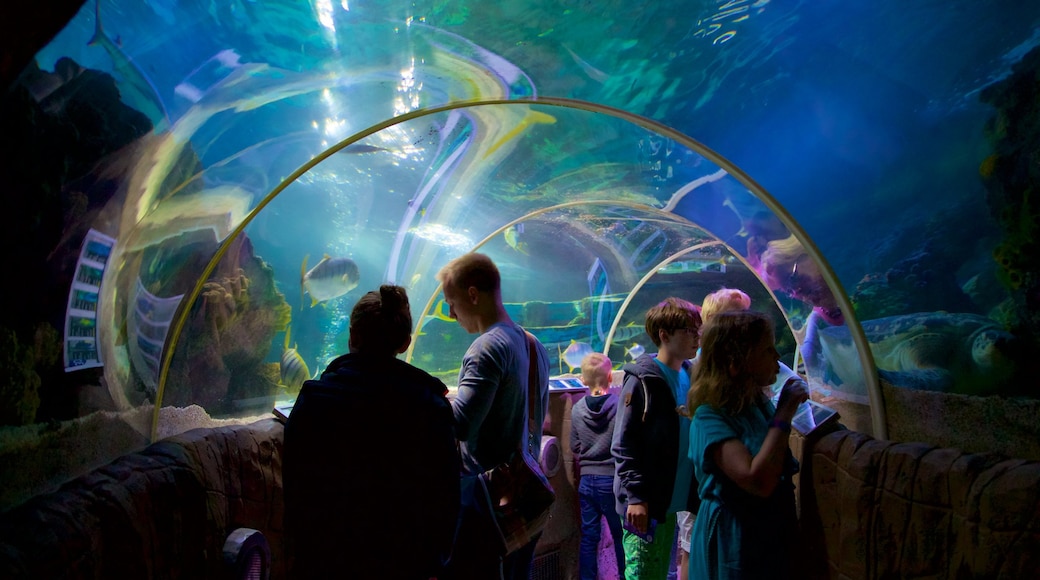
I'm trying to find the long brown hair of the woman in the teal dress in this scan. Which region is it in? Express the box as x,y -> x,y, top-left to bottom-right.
686,311 -> 774,417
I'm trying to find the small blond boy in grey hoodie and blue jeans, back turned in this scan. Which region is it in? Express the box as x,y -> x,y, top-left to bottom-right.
571,352 -> 625,580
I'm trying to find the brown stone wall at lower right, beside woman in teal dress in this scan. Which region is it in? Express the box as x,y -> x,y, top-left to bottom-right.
800,430 -> 1040,579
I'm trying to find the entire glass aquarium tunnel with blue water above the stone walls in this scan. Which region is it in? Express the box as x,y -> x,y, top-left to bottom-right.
0,0 -> 1040,509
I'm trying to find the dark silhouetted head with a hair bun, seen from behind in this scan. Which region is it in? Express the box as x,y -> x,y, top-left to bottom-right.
349,284 -> 412,357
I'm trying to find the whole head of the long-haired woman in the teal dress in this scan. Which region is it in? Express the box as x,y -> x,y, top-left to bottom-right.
687,311 -> 780,414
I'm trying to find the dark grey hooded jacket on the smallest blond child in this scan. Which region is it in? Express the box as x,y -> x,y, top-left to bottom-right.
571,393 -> 618,477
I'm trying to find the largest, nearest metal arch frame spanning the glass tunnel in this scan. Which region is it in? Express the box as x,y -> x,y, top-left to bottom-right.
151,97 -> 887,441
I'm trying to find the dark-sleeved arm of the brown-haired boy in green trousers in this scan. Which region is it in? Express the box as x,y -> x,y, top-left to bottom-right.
610,376 -> 649,533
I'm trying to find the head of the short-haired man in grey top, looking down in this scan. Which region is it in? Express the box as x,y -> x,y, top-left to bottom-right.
437,252 -> 502,333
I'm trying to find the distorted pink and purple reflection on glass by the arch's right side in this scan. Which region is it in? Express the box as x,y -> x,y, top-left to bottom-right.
759,236 -> 844,324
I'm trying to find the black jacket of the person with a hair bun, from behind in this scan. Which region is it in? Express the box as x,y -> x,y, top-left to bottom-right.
283,354 -> 461,580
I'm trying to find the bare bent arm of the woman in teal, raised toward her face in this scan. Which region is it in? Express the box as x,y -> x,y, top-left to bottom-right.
709,380 -> 809,497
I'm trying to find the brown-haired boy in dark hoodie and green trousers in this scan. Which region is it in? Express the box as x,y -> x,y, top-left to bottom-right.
610,297 -> 701,580
